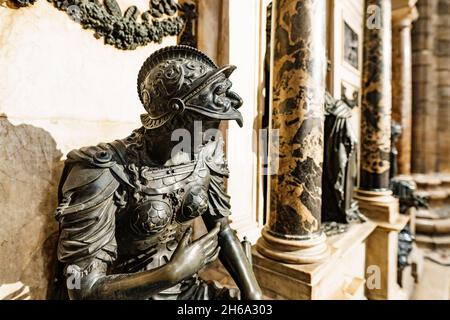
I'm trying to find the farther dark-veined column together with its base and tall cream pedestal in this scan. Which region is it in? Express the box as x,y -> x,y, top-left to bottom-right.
355,0 -> 409,299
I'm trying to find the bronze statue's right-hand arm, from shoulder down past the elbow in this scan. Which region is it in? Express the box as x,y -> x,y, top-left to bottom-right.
202,139 -> 262,300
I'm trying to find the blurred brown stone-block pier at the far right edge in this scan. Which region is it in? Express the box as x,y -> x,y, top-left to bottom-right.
412,0 -> 450,174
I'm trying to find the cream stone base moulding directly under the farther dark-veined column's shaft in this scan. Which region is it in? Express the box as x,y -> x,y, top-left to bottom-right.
355,189 -> 400,223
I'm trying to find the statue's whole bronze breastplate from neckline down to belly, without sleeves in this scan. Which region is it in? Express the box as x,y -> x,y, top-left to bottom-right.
112,159 -> 209,272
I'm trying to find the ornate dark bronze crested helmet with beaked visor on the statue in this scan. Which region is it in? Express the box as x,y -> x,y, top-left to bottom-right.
138,45 -> 242,129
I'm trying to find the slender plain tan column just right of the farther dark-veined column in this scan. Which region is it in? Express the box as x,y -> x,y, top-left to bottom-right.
392,0 -> 419,176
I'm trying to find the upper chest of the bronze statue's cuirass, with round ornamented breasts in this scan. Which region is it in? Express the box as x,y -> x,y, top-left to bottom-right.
126,161 -> 209,237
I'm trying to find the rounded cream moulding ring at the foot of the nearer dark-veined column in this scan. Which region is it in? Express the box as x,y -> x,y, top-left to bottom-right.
256,227 -> 330,264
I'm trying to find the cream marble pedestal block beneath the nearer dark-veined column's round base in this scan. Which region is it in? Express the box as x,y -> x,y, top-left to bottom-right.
253,221 -> 376,300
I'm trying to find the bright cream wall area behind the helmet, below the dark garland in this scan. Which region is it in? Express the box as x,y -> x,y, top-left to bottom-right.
0,0 -> 176,154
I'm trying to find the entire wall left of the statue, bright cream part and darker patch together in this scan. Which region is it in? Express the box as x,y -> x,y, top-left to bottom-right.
0,0 -> 176,299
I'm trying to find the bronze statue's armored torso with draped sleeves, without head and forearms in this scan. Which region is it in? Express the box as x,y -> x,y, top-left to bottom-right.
56,131 -> 230,299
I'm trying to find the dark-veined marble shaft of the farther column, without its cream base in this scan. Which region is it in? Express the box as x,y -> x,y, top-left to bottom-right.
360,0 -> 391,190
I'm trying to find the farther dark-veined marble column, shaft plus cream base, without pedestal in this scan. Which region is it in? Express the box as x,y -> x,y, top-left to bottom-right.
355,0 -> 399,223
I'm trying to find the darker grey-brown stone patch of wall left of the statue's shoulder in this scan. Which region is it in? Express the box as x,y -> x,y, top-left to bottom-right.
0,116 -> 62,298
